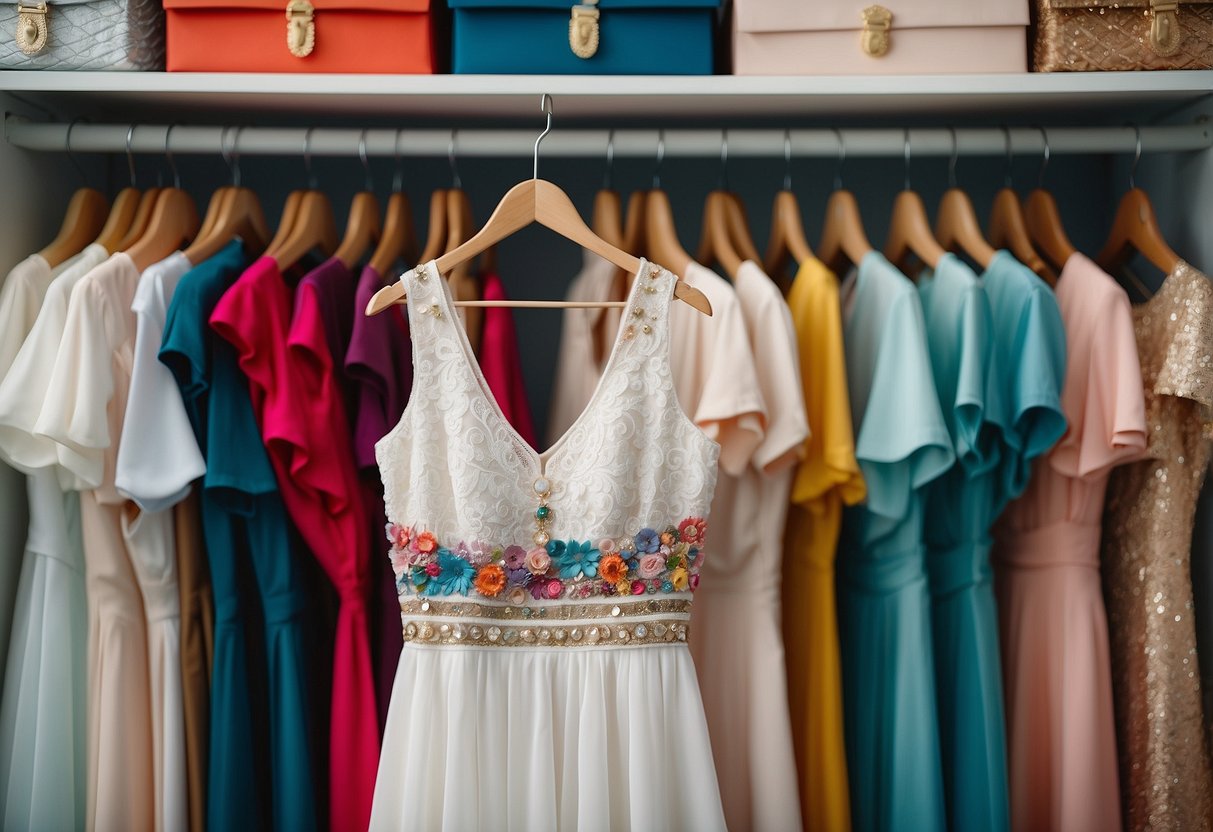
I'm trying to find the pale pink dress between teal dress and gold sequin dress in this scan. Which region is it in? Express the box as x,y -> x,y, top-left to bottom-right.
995,253 -> 1146,832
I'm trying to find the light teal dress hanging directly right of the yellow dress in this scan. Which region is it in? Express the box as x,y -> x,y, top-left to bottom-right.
838,251 -> 955,832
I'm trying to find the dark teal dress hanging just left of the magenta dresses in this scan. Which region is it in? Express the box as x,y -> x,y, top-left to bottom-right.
160,240 -> 318,832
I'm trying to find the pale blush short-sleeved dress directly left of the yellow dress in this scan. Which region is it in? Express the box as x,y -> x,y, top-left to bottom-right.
690,261 -> 809,830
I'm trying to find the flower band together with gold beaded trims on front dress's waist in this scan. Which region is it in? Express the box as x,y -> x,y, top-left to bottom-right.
387,518 -> 706,648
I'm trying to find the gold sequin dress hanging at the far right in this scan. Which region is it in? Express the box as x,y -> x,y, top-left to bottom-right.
1103,262 -> 1213,832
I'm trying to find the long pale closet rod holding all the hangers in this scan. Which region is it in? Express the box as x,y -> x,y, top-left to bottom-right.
5,115 -> 1213,159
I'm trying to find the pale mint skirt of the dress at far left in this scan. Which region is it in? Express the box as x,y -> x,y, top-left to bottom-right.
0,471 -> 89,832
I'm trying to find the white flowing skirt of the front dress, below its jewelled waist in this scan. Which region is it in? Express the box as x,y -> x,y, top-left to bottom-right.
370,643 -> 724,832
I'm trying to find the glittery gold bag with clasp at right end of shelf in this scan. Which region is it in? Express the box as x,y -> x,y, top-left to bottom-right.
1032,0 -> 1213,73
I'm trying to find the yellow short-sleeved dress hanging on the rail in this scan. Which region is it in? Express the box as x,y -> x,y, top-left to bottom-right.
782,258 -> 866,832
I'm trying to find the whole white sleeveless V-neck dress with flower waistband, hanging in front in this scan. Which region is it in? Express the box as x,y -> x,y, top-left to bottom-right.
370,262 -> 724,832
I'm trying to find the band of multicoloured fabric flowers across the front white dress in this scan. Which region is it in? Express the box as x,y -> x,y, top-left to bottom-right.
386,517 -> 706,606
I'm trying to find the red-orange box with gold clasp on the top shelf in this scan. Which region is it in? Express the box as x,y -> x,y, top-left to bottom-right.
164,0 -> 437,74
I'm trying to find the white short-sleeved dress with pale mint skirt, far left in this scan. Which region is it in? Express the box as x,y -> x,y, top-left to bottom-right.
0,245 -> 107,830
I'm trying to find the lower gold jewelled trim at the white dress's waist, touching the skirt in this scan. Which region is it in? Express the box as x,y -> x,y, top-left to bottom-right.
404,620 -> 690,648
